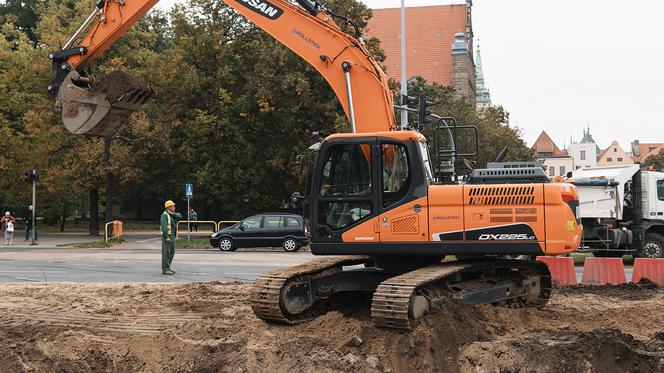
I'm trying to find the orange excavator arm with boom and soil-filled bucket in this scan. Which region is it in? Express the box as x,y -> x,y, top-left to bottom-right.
48,0 -> 396,136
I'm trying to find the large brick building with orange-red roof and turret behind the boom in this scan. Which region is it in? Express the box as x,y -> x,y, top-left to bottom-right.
366,0 -> 476,105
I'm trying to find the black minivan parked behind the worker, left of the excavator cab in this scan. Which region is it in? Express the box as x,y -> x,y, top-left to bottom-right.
210,212 -> 309,252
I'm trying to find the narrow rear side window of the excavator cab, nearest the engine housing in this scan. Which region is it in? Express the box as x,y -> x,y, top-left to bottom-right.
380,144 -> 411,207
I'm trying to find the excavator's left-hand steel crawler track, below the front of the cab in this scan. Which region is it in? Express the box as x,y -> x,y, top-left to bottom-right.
250,256 -> 371,324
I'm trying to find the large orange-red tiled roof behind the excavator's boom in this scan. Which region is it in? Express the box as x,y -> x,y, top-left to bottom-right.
366,4 -> 472,86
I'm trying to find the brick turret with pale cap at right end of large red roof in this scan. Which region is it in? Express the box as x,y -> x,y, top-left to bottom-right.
452,32 -> 476,107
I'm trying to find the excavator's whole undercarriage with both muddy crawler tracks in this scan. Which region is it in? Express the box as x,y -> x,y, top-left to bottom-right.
250,257 -> 551,330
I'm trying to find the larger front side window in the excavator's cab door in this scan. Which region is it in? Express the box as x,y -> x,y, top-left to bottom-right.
320,144 -> 371,196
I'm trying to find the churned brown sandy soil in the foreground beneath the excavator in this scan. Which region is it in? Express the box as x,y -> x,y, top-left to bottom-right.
0,283 -> 664,372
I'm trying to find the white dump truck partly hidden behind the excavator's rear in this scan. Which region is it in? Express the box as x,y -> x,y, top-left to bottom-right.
567,164 -> 664,258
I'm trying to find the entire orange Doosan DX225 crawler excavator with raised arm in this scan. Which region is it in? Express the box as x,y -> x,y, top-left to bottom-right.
49,0 -> 581,329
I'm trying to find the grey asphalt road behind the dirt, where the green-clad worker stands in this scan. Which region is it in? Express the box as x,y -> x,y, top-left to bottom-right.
0,232 -> 632,282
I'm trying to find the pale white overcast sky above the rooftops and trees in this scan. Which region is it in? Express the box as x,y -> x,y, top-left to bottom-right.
160,0 -> 664,151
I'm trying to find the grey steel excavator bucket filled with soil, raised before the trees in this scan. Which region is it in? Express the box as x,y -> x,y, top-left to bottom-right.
56,69 -> 154,136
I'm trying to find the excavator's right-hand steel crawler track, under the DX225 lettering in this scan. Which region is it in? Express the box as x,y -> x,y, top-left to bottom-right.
371,260 -> 551,330
